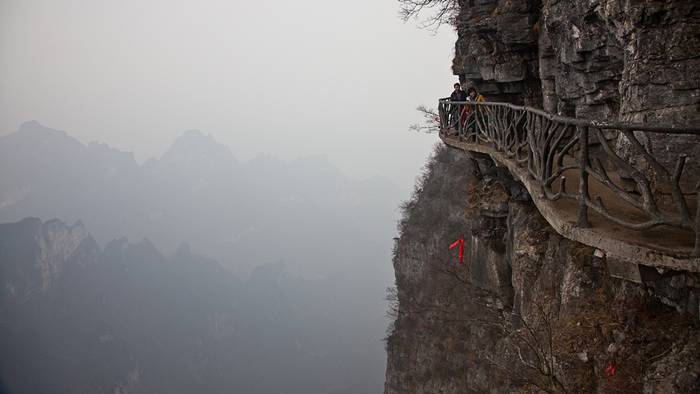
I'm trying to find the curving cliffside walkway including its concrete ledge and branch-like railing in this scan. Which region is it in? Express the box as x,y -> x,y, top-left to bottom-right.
438,100 -> 700,280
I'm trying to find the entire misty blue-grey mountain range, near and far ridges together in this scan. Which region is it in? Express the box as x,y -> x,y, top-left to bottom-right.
0,122 -> 402,393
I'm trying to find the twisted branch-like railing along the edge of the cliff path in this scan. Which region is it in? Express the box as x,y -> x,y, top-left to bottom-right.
438,100 -> 700,257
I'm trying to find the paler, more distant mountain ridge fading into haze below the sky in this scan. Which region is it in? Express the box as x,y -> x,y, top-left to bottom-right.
0,121 -> 403,278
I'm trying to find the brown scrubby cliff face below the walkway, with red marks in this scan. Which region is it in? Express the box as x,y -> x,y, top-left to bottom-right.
385,147 -> 700,393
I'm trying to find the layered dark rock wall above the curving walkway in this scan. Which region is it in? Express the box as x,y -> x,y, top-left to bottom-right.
453,0 -> 700,124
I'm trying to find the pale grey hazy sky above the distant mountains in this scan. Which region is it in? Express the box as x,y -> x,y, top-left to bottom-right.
0,0 -> 456,187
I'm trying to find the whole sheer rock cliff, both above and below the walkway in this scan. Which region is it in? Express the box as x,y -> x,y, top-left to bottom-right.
385,0 -> 700,394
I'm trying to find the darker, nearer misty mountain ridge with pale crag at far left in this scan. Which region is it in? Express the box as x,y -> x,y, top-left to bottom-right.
0,219 -> 384,394
